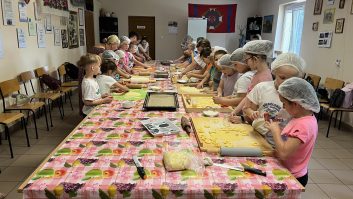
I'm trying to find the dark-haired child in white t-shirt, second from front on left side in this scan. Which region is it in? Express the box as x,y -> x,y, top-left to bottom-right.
96,60 -> 129,95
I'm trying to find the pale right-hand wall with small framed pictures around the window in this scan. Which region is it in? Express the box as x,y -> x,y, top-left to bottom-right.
259,0 -> 353,126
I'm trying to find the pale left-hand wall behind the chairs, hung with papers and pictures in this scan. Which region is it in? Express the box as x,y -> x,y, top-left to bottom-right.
0,1 -> 86,81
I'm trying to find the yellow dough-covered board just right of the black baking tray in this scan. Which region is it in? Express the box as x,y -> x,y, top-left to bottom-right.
182,94 -> 232,113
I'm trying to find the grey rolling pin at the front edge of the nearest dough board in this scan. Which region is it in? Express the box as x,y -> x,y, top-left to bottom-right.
207,147 -> 264,157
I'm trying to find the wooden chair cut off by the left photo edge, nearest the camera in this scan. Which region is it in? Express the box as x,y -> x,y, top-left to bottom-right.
0,113 -> 30,158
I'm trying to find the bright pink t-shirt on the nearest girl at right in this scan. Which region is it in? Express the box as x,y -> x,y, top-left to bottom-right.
282,116 -> 318,178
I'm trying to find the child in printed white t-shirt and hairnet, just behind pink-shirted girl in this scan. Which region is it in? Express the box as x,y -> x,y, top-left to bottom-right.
243,53 -> 305,146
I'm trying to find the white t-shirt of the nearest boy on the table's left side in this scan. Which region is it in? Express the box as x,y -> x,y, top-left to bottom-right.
81,78 -> 102,115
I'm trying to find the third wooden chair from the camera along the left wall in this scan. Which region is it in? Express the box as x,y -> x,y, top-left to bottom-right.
20,71 -> 64,126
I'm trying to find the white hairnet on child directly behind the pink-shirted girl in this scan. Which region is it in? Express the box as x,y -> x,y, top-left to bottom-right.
271,53 -> 306,77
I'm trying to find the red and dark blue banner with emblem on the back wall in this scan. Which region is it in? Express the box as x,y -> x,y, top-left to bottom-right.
189,4 -> 237,33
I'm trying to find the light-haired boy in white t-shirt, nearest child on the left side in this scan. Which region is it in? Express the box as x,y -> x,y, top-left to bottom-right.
77,54 -> 113,116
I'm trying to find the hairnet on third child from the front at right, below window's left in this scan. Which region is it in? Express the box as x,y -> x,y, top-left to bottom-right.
243,40 -> 273,57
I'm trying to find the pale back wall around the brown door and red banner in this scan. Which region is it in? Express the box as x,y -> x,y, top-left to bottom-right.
96,0 -> 258,59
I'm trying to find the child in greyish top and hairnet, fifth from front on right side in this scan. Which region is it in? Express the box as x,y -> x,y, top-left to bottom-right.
217,54 -> 239,97
